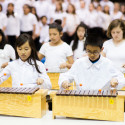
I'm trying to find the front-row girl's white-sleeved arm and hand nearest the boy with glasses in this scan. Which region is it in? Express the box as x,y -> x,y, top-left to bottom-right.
37,62 -> 52,89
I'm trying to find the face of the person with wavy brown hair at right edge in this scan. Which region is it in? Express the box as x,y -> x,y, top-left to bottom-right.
111,27 -> 123,42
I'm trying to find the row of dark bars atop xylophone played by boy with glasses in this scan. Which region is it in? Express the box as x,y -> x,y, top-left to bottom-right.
56,90 -> 118,97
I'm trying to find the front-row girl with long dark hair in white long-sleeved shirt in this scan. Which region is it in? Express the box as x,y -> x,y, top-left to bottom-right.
0,34 -> 51,89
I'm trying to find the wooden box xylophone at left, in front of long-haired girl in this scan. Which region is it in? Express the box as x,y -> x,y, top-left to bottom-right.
0,87 -> 48,118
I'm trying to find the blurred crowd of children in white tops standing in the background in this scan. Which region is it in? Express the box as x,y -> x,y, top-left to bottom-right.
0,0 -> 124,50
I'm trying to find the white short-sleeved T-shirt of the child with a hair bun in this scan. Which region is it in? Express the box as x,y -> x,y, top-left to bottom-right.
39,42 -> 73,72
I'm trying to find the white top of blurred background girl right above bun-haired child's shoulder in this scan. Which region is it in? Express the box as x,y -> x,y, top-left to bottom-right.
65,14 -> 80,32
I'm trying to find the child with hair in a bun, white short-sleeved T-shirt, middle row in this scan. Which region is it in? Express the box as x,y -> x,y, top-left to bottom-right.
39,23 -> 73,72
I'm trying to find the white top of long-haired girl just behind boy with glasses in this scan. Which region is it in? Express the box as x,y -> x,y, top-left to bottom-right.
70,38 -> 85,60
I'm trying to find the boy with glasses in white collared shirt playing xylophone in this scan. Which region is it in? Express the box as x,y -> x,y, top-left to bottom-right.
59,34 -> 125,90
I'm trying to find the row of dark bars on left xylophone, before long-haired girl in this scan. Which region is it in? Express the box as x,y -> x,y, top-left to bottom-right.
0,87 -> 39,94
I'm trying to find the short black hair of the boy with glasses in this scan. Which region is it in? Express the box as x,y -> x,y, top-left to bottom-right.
84,34 -> 103,50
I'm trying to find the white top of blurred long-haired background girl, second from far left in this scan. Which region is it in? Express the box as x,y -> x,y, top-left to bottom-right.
5,15 -> 20,36
